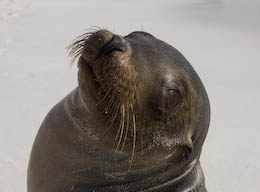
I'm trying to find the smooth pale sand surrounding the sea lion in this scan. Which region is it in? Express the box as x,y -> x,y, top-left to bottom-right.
0,0 -> 260,192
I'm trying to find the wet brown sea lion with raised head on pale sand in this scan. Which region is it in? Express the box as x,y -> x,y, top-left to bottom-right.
28,29 -> 210,192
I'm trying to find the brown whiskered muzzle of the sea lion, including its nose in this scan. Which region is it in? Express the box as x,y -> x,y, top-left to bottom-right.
71,30 -> 135,100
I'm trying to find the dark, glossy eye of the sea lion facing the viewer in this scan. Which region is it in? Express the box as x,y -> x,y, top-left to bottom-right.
162,89 -> 180,110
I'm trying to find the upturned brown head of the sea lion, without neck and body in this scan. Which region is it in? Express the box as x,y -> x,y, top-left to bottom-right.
68,30 -> 209,173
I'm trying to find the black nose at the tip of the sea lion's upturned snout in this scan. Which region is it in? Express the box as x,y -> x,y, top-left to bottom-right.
99,35 -> 127,57
